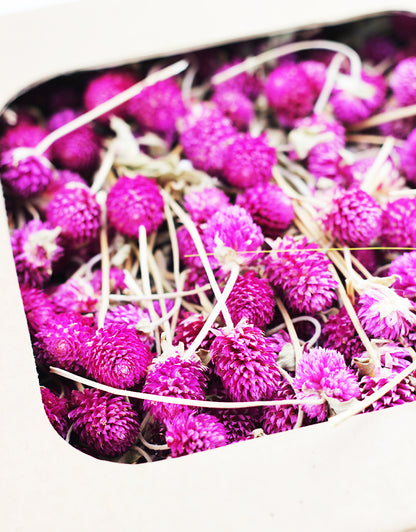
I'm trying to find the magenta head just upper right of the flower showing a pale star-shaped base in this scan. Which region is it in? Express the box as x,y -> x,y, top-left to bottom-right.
46,182 -> 101,249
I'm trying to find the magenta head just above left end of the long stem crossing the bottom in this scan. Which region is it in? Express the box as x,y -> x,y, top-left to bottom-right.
34,312 -> 93,372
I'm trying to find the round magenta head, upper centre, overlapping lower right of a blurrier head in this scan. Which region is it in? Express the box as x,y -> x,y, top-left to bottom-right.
223,133 -> 277,188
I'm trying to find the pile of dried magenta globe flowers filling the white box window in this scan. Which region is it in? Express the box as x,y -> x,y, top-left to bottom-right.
0,11 -> 416,463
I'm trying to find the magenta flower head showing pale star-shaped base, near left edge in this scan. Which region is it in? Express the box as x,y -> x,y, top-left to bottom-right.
10,220 -> 63,287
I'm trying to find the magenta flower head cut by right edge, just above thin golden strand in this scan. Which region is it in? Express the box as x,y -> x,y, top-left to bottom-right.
381,198 -> 416,248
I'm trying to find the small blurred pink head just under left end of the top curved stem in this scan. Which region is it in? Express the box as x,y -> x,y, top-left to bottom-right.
211,90 -> 255,131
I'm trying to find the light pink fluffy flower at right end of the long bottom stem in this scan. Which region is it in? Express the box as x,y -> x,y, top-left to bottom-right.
293,347 -> 360,421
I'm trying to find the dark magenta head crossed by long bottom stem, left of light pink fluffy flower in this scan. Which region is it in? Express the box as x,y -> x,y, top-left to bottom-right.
261,380 -> 298,434
